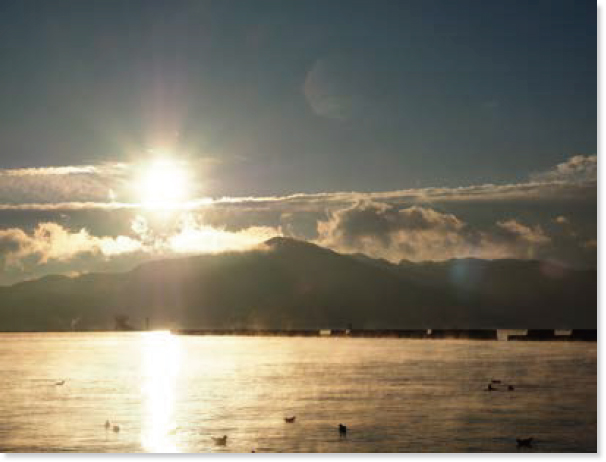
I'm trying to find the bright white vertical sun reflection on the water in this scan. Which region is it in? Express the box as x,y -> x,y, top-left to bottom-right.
141,331 -> 181,453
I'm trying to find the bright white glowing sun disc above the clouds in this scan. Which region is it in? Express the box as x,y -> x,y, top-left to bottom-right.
136,159 -> 191,208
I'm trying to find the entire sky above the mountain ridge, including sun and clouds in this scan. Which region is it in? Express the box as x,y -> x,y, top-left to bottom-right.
0,0 -> 597,284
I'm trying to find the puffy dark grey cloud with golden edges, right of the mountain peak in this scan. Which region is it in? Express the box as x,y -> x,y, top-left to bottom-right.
317,202 -> 551,262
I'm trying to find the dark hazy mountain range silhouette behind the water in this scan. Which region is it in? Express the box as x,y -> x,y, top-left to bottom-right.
0,237 -> 597,331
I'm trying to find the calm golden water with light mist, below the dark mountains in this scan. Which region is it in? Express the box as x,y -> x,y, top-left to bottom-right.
0,333 -> 597,452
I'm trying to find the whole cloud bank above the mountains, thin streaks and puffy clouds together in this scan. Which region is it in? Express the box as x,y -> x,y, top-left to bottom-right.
0,156 -> 597,280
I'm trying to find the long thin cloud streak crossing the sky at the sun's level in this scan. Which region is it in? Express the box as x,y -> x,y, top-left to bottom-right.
0,156 -> 597,213
